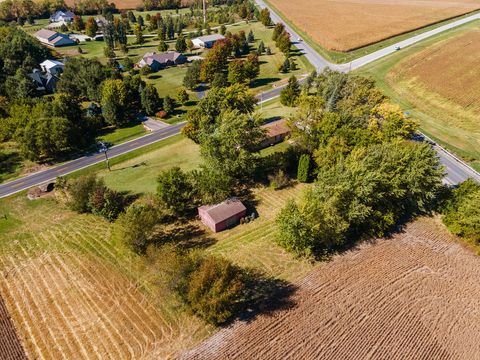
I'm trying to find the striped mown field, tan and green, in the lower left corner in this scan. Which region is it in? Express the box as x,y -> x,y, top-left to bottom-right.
0,197 -> 206,359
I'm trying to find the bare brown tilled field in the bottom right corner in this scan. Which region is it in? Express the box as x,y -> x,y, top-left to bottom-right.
183,219 -> 480,359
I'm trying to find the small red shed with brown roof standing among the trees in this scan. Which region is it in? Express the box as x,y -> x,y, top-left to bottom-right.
198,199 -> 247,232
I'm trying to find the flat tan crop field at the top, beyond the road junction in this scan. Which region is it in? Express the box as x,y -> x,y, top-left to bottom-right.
269,0 -> 480,51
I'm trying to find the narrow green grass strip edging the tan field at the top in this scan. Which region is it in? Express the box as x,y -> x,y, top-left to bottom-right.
264,0 -> 480,64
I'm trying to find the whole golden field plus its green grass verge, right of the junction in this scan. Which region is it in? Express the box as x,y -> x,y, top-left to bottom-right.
359,22 -> 480,169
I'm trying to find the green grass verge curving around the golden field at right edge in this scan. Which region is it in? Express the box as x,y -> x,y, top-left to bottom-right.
357,21 -> 480,170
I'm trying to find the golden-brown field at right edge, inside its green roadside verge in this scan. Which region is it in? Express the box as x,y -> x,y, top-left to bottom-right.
386,26 -> 480,158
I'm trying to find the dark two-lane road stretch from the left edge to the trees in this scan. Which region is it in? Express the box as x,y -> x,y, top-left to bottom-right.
0,123 -> 185,198
